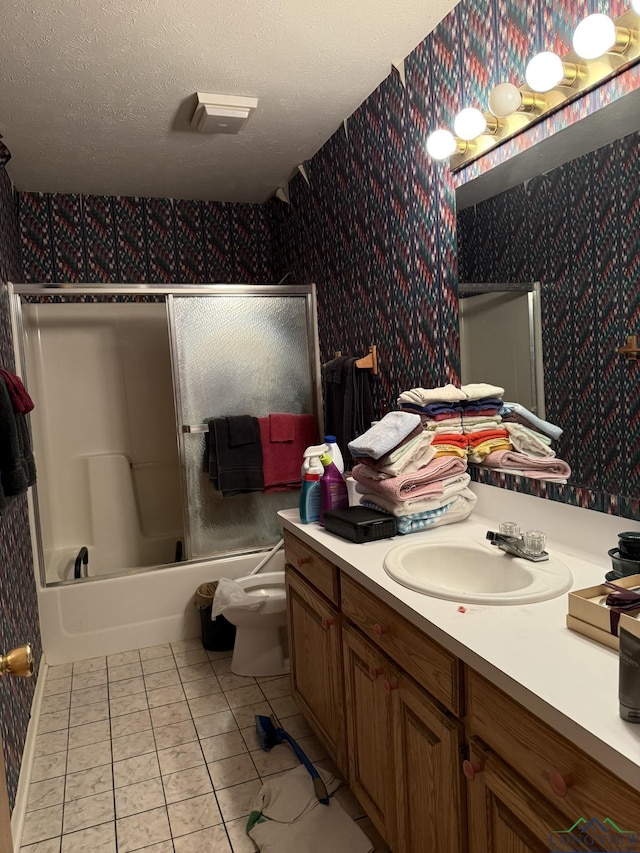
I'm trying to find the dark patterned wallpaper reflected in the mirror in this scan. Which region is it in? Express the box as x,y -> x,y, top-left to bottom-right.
458,133 -> 640,497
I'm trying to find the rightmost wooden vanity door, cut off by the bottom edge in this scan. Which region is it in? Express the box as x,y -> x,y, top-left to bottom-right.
464,738 -> 602,853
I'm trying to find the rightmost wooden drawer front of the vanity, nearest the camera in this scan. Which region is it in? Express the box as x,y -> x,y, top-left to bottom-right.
465,668 -> 640,830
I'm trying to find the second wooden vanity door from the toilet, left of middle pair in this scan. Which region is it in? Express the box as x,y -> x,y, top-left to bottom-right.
343,623 -> 395,847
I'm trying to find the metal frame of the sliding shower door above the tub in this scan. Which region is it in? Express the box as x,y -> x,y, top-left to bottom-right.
7,282 -> 324,588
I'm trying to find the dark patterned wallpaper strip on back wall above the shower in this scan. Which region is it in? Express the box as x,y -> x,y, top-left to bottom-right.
18,193 -> 273,284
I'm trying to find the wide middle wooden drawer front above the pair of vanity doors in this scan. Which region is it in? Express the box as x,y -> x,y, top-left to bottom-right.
340,574 -> 462,716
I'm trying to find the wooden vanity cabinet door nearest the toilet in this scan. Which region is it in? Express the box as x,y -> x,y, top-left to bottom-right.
286,568 -> 346,773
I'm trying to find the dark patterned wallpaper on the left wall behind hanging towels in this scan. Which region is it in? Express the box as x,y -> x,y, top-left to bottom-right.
0,169 -> 42,807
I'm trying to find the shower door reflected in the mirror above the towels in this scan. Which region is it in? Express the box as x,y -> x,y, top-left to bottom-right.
458,282 -> 545,418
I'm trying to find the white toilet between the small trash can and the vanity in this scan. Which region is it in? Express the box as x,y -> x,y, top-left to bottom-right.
224,552 -> 289,676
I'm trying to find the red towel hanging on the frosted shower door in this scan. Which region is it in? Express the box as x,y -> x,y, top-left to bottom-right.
258,415 -> 319,492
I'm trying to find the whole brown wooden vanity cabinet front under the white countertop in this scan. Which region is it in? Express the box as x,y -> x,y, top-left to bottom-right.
287,537 -> 640,853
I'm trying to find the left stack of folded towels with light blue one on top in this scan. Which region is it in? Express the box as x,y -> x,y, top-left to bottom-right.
349,411 -> 476,533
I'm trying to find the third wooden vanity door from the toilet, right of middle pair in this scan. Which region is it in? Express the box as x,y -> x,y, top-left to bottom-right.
391,672 -> 462,853
